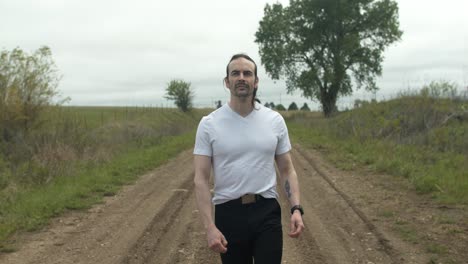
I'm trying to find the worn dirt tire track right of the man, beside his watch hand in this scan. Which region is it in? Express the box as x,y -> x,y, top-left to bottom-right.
285,148 -> 399,264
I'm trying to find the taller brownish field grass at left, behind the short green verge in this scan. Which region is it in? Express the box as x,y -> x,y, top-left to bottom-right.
0,107 -> 207,187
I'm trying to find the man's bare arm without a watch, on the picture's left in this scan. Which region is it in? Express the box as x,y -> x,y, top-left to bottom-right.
194,155 -> 227,253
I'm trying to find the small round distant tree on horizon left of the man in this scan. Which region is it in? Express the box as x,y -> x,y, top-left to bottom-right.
165,80 -> 194,112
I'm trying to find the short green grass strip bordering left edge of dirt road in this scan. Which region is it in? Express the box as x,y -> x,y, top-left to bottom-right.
0,131 -> 194,252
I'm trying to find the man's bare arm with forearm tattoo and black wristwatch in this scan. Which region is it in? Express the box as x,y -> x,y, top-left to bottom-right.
275,152 -> 304,237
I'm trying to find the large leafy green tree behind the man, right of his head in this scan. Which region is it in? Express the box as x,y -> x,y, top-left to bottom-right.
255,0 -> 402,116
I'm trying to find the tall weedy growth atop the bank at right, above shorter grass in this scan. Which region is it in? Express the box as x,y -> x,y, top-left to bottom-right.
330,96 -> 468,153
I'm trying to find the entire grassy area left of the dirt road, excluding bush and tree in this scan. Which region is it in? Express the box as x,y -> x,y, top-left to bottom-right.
0,107 -> 210,251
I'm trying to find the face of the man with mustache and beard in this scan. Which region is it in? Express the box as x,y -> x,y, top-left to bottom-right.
225,58 -> 258,98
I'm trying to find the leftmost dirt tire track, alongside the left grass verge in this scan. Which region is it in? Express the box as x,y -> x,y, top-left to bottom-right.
0,151 -> 208,264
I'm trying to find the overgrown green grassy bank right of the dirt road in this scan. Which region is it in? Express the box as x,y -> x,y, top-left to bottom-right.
286,81 -> 468,204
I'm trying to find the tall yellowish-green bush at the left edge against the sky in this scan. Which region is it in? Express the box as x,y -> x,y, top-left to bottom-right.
0,47 -> 63,141
